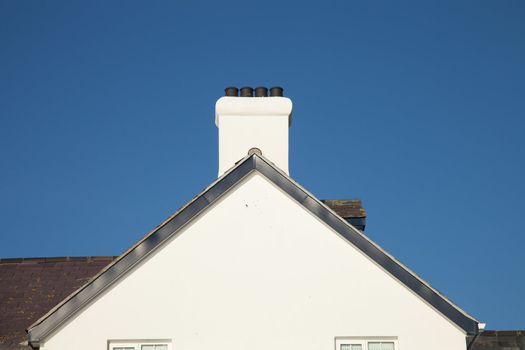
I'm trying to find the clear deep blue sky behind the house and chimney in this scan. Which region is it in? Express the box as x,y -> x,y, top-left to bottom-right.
0,1 -> 525,329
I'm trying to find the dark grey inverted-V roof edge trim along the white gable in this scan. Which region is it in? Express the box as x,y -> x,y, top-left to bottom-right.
28,154 -> 478,347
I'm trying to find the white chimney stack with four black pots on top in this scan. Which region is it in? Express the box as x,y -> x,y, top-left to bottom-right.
215,87 -> 292,176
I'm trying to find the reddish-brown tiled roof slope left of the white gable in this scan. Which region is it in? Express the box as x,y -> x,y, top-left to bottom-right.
0,256 -> 114,349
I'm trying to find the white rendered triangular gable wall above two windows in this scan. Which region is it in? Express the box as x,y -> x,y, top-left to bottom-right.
43,174 -> 466,350
